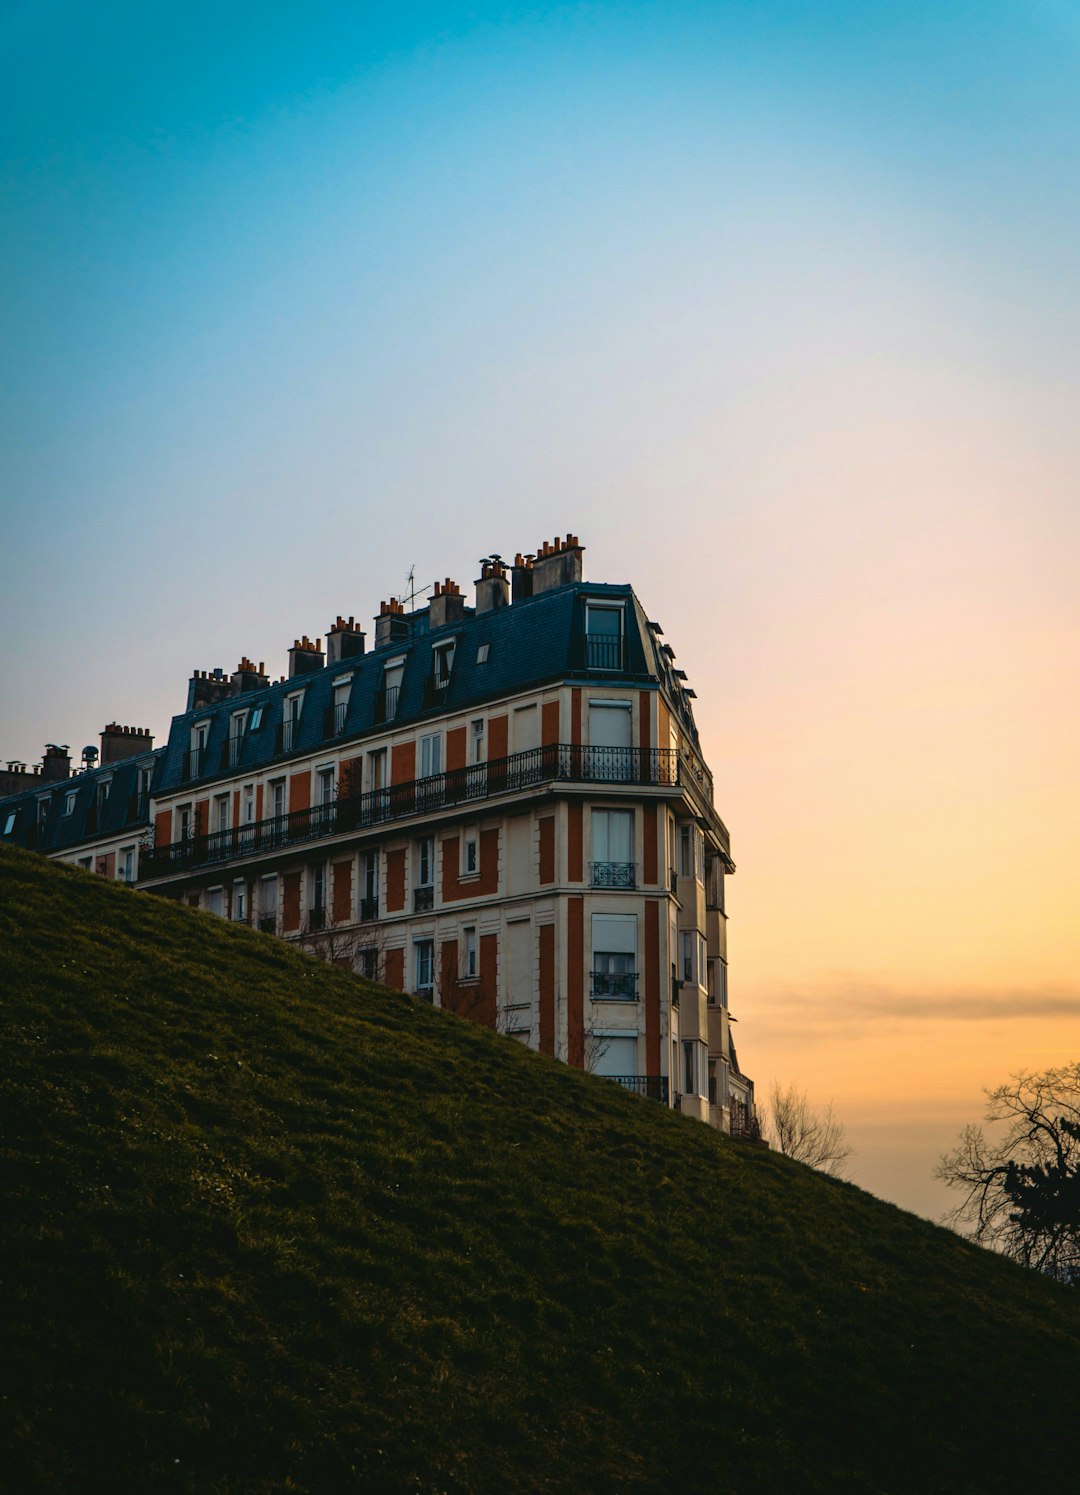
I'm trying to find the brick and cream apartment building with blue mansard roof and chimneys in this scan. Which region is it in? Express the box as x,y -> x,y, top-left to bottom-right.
0,535 -> 752,1132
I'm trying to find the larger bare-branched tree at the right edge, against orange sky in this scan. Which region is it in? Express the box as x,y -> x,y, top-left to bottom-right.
935,1063 -> 1080,1286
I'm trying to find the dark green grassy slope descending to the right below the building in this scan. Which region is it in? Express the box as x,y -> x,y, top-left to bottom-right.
0,851 -> 1080,1492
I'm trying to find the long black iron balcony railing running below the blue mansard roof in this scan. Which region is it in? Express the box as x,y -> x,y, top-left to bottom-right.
142,743 -> 681,879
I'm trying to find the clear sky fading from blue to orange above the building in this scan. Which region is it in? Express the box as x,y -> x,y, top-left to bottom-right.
0,0 -> 1080,1217
